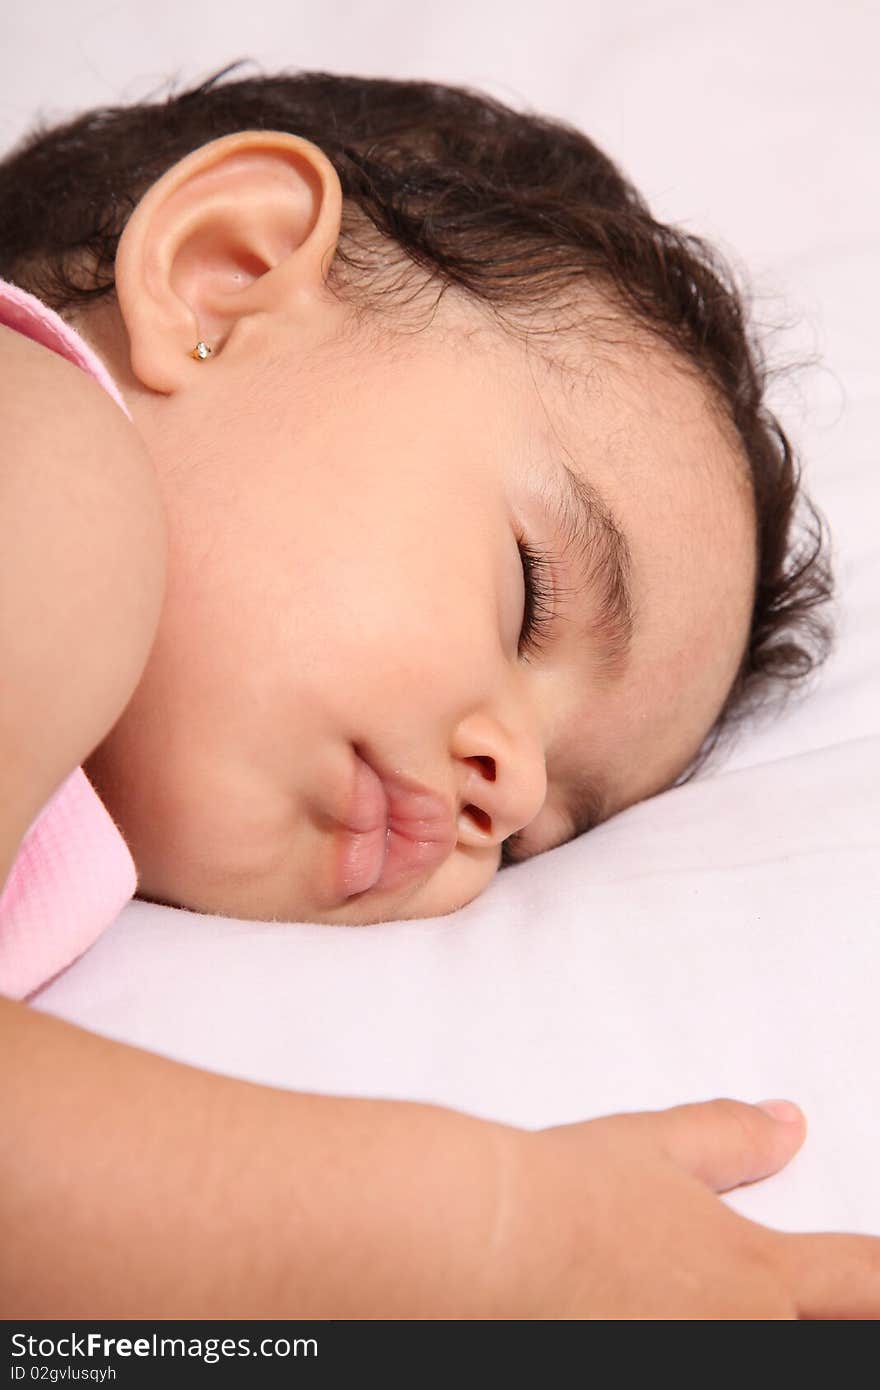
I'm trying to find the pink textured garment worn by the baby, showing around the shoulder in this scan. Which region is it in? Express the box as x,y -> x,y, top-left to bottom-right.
0,279 -> 138,999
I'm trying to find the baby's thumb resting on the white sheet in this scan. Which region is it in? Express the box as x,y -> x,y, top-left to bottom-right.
641,1099 -> 806,1193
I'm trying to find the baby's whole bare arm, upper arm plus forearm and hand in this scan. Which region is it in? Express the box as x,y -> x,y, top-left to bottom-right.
0,344 -> 880,1318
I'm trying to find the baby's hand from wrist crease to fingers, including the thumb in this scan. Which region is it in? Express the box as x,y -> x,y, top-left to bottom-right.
491,1099 -> 880,1321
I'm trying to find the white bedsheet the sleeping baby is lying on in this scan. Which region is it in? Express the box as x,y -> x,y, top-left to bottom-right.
8,0 -> 880,1233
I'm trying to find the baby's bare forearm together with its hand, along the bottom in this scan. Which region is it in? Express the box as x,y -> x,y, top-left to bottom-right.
6,1001 -> 880,1319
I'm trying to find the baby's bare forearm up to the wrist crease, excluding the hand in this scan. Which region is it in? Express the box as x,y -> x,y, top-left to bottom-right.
0,1001 -> 503,1318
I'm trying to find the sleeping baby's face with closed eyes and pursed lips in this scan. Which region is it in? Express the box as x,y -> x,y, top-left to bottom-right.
86,296 -> 753,924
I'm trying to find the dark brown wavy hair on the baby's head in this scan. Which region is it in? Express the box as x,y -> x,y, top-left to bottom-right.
0,60 -> 834,811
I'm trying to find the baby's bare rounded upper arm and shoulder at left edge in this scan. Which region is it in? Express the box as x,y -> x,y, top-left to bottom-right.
0,325 -> 167,887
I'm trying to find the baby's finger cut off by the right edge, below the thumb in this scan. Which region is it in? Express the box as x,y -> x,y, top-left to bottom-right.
777,1234 -> 880,1319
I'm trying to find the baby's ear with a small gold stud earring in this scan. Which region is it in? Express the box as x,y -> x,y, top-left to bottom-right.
115,131 -> 342,395
